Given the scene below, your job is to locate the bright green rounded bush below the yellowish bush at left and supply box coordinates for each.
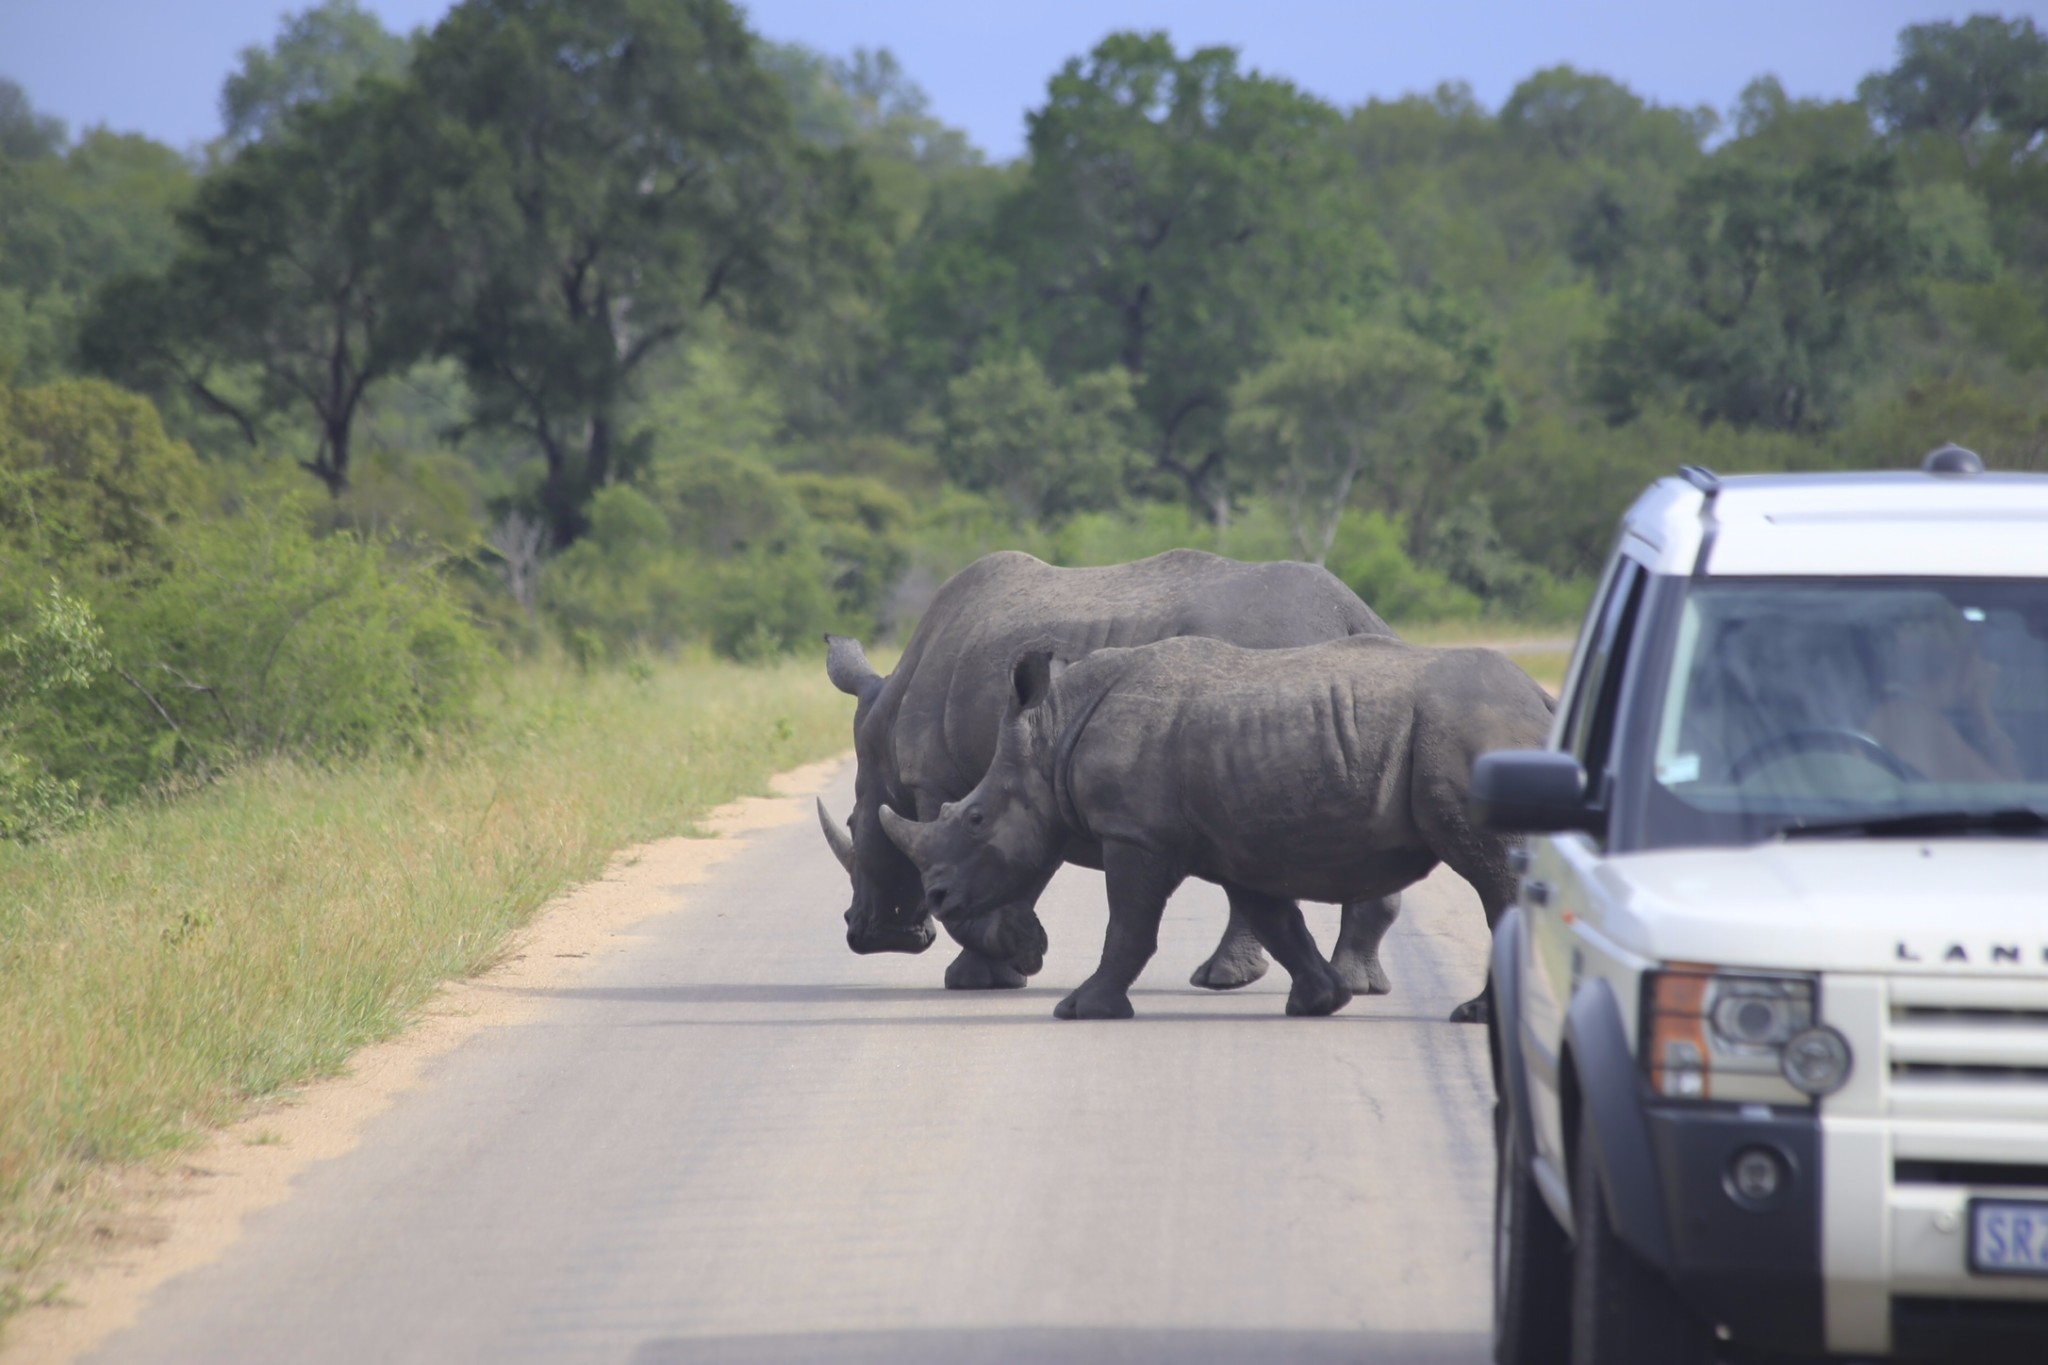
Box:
[35,505,489,800]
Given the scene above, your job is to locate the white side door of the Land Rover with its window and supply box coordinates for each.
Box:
[1522,551,1649,1177]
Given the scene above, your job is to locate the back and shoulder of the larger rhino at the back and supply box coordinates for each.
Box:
[874,551,1391,800]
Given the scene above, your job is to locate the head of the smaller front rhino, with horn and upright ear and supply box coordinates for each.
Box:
[881,651,1067,931]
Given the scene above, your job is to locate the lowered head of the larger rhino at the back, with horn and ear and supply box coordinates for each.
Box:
[817,634,938,954]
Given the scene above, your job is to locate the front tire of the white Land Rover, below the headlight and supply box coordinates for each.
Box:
[1571,1115,1718,1365]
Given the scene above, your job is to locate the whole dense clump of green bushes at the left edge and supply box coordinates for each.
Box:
[0,381,489,833]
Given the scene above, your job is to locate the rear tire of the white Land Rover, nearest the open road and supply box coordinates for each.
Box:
[1493,1099,1571,1365]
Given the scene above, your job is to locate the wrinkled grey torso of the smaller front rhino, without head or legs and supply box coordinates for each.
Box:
[1055,639,1548,900]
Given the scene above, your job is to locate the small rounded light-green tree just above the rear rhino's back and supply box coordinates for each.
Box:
[938,354,1145,522]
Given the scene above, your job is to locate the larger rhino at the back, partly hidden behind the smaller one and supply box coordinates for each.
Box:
[817,551,1399,993]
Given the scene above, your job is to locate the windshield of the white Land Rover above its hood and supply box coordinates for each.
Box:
[1645,579,2048,847]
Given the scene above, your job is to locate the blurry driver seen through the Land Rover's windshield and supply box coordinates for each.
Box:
[1864,604,2023,782]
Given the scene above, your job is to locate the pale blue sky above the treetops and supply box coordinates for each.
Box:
[0,0,2048,160]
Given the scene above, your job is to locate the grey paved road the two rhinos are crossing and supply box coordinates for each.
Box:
[92,774,1491,1365]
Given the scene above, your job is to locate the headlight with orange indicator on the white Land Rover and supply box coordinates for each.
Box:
[1640,968,1849,1105]
